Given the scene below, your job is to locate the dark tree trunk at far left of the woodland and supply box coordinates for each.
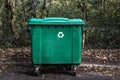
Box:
[3,0,13,36]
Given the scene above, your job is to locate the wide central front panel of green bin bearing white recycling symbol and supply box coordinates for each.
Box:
[41,26,72,64]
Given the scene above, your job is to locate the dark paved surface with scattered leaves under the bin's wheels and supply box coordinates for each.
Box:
[0,65,120,80]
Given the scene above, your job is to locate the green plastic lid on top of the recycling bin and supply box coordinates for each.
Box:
[28,17,85,25]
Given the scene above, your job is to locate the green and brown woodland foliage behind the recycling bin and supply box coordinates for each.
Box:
[0,0,120,48]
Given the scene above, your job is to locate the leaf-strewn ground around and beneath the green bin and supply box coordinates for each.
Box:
[0,48,120,80]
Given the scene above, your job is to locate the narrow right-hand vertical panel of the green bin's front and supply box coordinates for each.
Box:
[73,26,82,64]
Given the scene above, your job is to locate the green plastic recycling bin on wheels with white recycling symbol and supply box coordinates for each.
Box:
[28,17,85,75]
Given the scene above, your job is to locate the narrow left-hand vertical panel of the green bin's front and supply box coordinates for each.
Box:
[31,27,41,64]
